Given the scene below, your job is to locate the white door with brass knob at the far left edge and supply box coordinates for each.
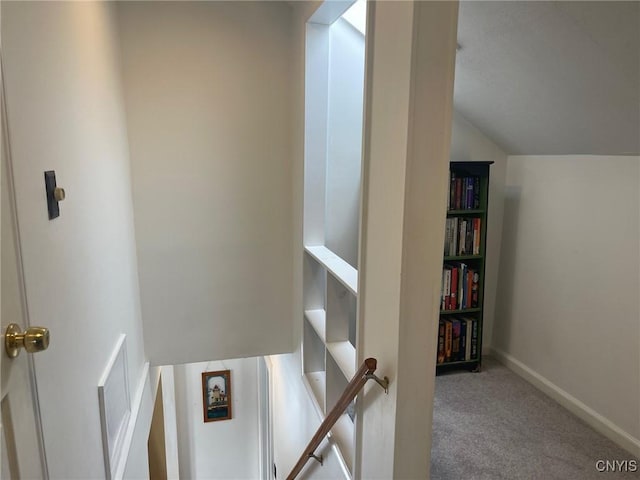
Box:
[0,65,47,480]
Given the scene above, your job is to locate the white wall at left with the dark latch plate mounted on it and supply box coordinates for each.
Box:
[1,2,148,478]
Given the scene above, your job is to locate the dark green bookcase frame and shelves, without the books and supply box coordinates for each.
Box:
[436,162,493,374]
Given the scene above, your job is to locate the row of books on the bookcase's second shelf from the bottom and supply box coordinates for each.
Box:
[440,262,480,310]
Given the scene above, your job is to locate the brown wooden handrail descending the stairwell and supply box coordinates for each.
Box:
[287,358,386,480]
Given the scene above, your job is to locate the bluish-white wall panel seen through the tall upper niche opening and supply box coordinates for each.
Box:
[325,19,364,268]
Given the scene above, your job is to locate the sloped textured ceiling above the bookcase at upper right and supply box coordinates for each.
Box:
[454,1,640,155]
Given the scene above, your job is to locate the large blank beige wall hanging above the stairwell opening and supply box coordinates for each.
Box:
[117,2,293,364]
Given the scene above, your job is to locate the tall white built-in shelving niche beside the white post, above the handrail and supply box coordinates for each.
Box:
[301,2,365,475]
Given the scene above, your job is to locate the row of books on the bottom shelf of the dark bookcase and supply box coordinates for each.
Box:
[437,317,478,364]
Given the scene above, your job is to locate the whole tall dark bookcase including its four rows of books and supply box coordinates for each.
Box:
[436,162,493,373]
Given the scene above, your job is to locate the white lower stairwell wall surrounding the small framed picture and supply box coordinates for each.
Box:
[174,358,260,480]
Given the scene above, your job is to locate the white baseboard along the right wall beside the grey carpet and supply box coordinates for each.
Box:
[488,348,640,458]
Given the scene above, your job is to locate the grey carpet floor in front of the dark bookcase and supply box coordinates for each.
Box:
[431,358,640,480]
